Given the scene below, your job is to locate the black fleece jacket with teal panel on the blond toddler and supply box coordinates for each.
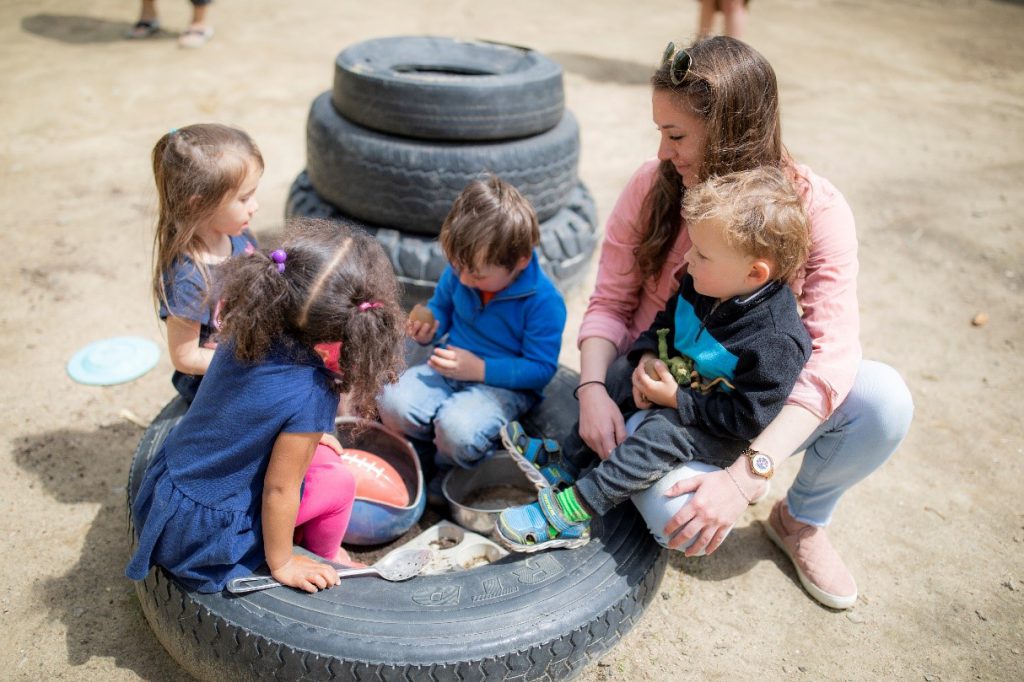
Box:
[629,274,811,440]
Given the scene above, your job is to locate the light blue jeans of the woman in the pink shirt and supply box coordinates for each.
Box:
[632,360,913,549]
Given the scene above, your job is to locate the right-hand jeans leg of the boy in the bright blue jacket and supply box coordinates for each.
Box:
[434,382,537,469]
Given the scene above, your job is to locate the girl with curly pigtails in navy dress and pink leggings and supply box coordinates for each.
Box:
[125,219,404,592]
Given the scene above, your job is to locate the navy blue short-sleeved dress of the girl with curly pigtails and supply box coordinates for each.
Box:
[125,342,338,592]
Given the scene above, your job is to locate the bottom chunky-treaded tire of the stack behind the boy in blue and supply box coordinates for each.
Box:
[285,171,598,306]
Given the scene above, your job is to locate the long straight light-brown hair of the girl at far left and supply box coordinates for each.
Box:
[153,123,263,305]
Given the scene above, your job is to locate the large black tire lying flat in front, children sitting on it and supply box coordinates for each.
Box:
[128,369,667,681]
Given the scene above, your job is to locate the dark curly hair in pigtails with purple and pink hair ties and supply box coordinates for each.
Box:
[218,218,406,417]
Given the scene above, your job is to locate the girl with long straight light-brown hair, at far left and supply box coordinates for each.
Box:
[153,123,263,402]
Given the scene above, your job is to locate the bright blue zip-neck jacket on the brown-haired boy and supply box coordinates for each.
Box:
[428,253,565,395]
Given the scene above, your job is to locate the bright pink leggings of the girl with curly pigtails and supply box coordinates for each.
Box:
[295,445,355,561]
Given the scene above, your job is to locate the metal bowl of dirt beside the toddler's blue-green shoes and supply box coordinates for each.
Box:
[441,452,537,535]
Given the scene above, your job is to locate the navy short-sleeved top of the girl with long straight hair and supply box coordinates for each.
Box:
[160,230,256,402]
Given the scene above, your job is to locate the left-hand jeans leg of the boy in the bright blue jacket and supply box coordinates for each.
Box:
[377,365,457,456]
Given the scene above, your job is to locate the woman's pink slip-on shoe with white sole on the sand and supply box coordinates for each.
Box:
[764,500,857,609]
